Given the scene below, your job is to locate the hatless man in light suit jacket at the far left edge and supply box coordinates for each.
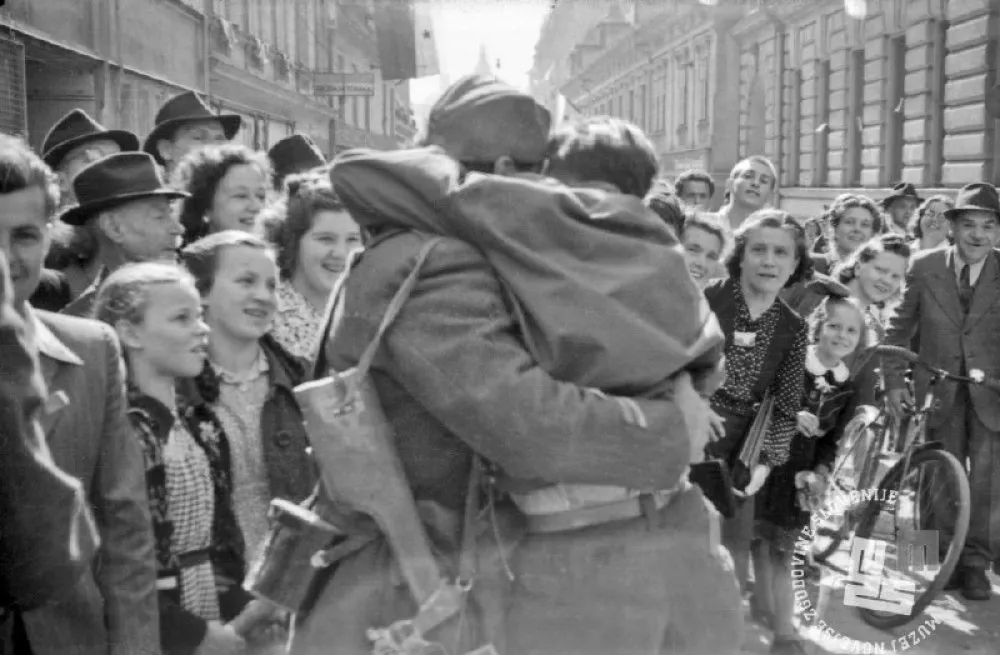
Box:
[0,136,159,655]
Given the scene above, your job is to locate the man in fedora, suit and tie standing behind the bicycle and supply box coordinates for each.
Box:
[883,182,1000,600]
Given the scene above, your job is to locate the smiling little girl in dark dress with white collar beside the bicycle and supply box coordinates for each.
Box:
[752,297,865,653]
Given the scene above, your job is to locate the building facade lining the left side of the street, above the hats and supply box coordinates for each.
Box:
[0,0,408,155]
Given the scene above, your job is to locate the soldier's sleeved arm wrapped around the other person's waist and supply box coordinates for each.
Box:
[342,236,701,489]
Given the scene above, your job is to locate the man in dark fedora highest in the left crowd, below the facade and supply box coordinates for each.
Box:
[142,91,243,176]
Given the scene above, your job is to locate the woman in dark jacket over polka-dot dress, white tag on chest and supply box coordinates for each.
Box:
[705,209,812,600]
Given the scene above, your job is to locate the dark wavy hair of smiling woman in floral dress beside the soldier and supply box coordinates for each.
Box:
[261,173,345,278]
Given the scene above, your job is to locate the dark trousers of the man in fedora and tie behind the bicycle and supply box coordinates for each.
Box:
[927,385,1000,569]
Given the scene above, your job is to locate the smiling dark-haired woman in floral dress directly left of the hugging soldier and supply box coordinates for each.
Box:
[261,173,361,360]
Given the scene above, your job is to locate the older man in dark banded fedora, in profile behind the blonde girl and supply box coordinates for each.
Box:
[59,152,188,316]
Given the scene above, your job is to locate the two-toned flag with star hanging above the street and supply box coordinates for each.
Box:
[375,0,440,80]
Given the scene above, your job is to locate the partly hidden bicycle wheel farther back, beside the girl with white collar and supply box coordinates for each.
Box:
[812,408,889,563]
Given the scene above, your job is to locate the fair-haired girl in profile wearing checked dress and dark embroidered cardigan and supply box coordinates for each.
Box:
[95,263,276,655]
